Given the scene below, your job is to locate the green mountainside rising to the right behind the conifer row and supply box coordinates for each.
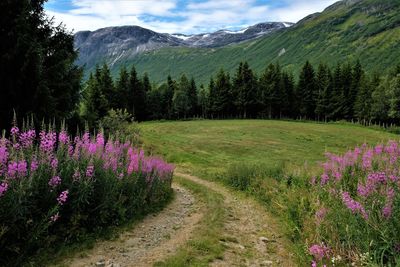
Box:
[108,0,400,82]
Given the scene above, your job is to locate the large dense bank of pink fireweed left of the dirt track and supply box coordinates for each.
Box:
[0,123,173,266]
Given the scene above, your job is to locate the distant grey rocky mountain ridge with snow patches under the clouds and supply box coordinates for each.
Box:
[75,22,293,73]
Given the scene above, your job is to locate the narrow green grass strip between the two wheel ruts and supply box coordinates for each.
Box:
[155,177,226,267]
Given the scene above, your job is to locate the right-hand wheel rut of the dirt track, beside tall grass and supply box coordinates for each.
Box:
[175,172,297,267]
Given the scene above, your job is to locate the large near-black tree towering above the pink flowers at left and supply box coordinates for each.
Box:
[0,0,82,129]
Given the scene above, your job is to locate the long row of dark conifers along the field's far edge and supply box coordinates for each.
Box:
[81,61,400,125]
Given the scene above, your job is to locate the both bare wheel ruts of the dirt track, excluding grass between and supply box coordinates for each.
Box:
[63,173,296,267]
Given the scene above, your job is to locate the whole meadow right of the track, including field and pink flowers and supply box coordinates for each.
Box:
[140,120,399,266]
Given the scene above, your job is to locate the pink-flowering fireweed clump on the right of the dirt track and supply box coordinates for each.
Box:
[310,141,400,266]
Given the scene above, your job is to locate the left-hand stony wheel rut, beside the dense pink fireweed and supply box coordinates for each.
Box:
[62,184,202,267]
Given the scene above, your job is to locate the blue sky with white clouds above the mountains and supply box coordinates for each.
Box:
[45,0,337,34]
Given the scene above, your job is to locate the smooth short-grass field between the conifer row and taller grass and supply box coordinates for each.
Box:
[140,120,398,178]
